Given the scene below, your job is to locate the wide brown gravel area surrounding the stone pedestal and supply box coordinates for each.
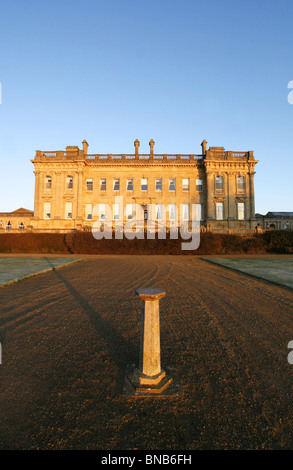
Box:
[0,256,293,450]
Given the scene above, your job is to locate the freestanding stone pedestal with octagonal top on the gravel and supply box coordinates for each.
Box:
[128,289,172,394]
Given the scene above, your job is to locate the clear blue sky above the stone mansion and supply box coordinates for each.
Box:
[0,0,293,213]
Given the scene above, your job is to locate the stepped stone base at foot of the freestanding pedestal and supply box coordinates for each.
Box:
[125,365,173,395]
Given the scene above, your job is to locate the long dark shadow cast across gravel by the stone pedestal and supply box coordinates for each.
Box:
[46,258,139,393]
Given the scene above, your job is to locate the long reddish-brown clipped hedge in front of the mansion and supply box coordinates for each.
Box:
[0,230,293,256]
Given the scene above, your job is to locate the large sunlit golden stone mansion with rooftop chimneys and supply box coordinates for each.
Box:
[0,140,257,232]
